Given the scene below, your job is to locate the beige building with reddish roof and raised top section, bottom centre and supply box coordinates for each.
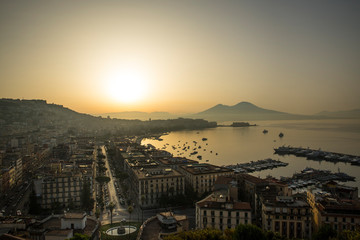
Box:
[195,191,251,230]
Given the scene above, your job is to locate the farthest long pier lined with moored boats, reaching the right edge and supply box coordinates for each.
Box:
[274,146,360,166]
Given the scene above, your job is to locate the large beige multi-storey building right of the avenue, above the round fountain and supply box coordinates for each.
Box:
[130,167,185,208]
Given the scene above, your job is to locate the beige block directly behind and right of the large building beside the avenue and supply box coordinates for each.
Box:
[179,163,234,195]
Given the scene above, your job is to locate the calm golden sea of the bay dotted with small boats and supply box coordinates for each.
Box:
[141,119,360,191]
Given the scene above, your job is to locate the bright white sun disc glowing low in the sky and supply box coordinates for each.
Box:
[107,68,147,104]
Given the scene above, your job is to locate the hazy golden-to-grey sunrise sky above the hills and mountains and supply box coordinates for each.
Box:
[0,0,360,114]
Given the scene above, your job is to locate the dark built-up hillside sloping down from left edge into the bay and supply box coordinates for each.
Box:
[0,99,216,136]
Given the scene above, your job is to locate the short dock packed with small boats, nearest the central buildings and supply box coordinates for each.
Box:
[224,158,289,173]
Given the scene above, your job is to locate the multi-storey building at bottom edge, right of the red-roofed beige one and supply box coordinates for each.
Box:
[261,196,312,239]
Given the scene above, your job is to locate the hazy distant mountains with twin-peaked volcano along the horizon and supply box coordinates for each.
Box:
[99,102,360,122]
